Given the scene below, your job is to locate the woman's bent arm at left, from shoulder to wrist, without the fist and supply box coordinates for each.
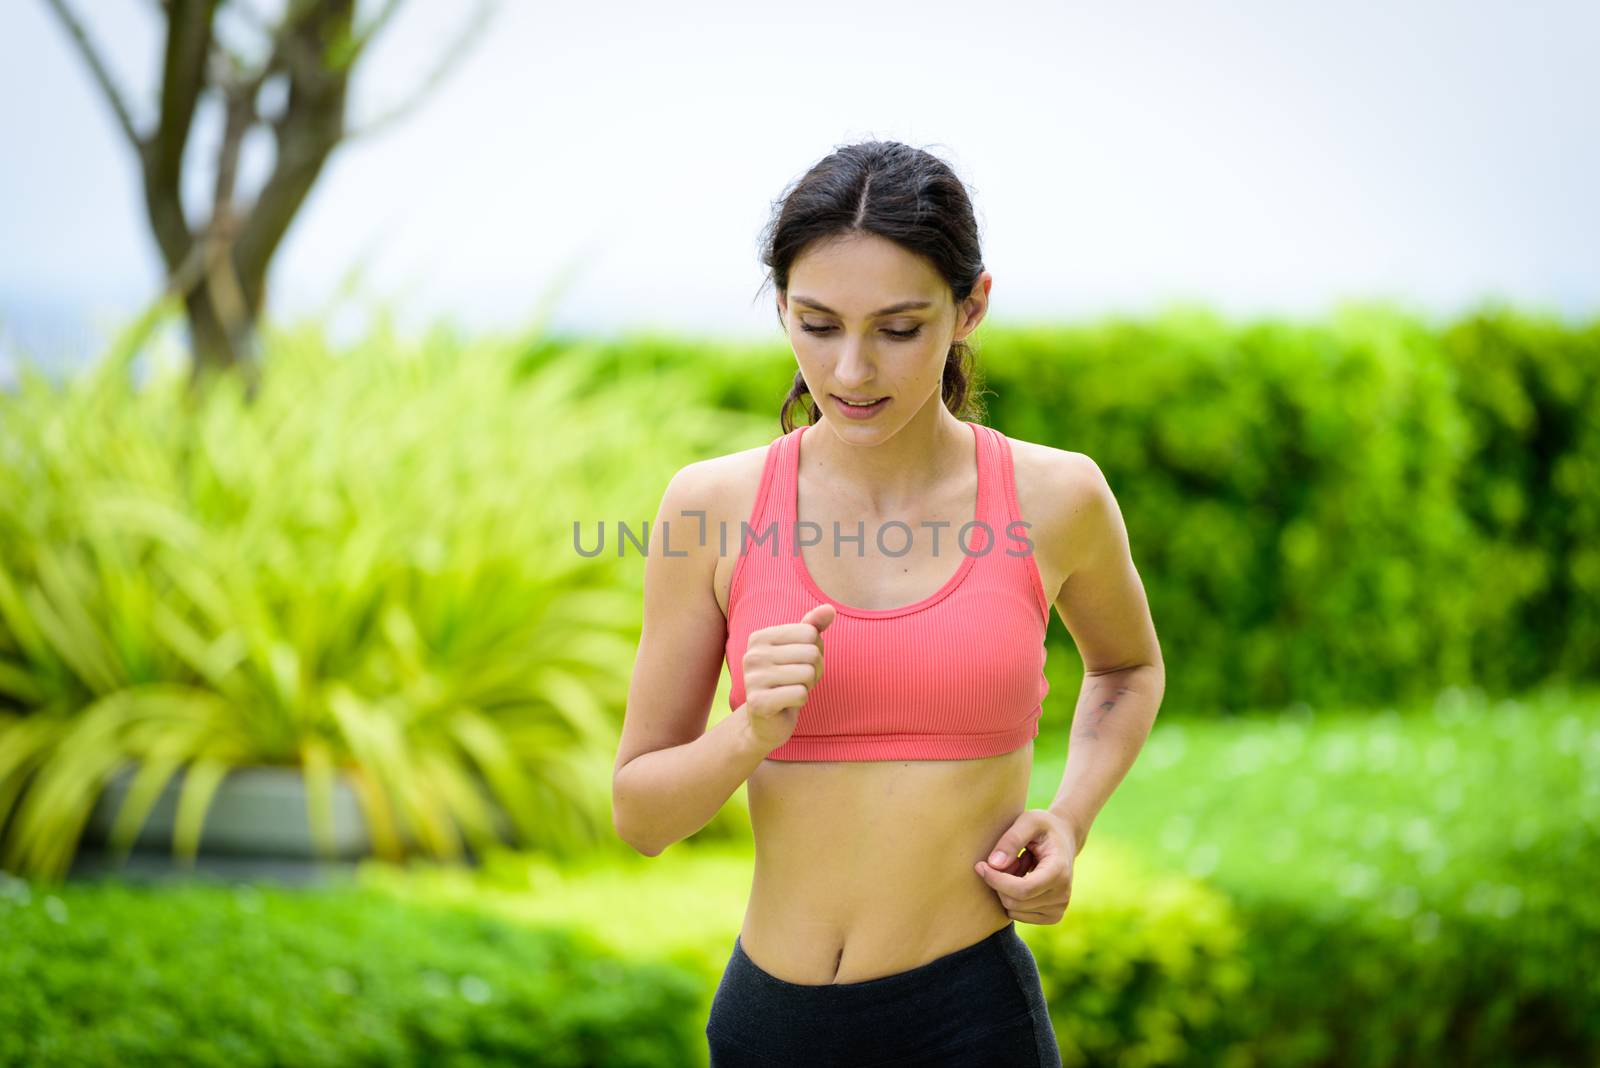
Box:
[611,460,770,857]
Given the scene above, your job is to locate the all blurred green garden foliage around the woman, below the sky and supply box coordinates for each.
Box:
[0,295,1600,1065]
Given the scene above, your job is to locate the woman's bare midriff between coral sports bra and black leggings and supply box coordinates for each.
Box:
[739,742,1034,985]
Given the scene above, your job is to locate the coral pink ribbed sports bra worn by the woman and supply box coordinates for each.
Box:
[725,420,1050,761]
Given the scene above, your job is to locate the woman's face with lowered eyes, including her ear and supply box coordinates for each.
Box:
[778,235,990,428]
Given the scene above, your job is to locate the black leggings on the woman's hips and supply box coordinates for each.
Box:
[706,921,1061,1068]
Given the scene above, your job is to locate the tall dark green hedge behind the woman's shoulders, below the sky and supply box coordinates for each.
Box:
[630,305,1600,711]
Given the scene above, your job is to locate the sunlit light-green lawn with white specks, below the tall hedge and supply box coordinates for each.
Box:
[1029,689,1600,924]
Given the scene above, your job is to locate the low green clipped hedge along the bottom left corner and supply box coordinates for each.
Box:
[0,876,706,1068]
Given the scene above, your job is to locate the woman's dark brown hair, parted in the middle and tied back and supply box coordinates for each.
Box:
[762,141,984,433]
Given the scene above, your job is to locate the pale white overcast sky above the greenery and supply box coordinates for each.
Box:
[0,0,1600,370]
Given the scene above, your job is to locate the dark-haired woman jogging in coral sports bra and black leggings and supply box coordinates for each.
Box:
[613,142,1165,1068]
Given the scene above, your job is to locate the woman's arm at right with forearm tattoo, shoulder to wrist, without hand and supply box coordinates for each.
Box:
[1048,452,1166,851]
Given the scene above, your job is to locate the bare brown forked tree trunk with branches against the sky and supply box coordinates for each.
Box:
[46,0,486,381]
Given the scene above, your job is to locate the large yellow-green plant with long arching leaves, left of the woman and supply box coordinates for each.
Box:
[0,294,771,879]
